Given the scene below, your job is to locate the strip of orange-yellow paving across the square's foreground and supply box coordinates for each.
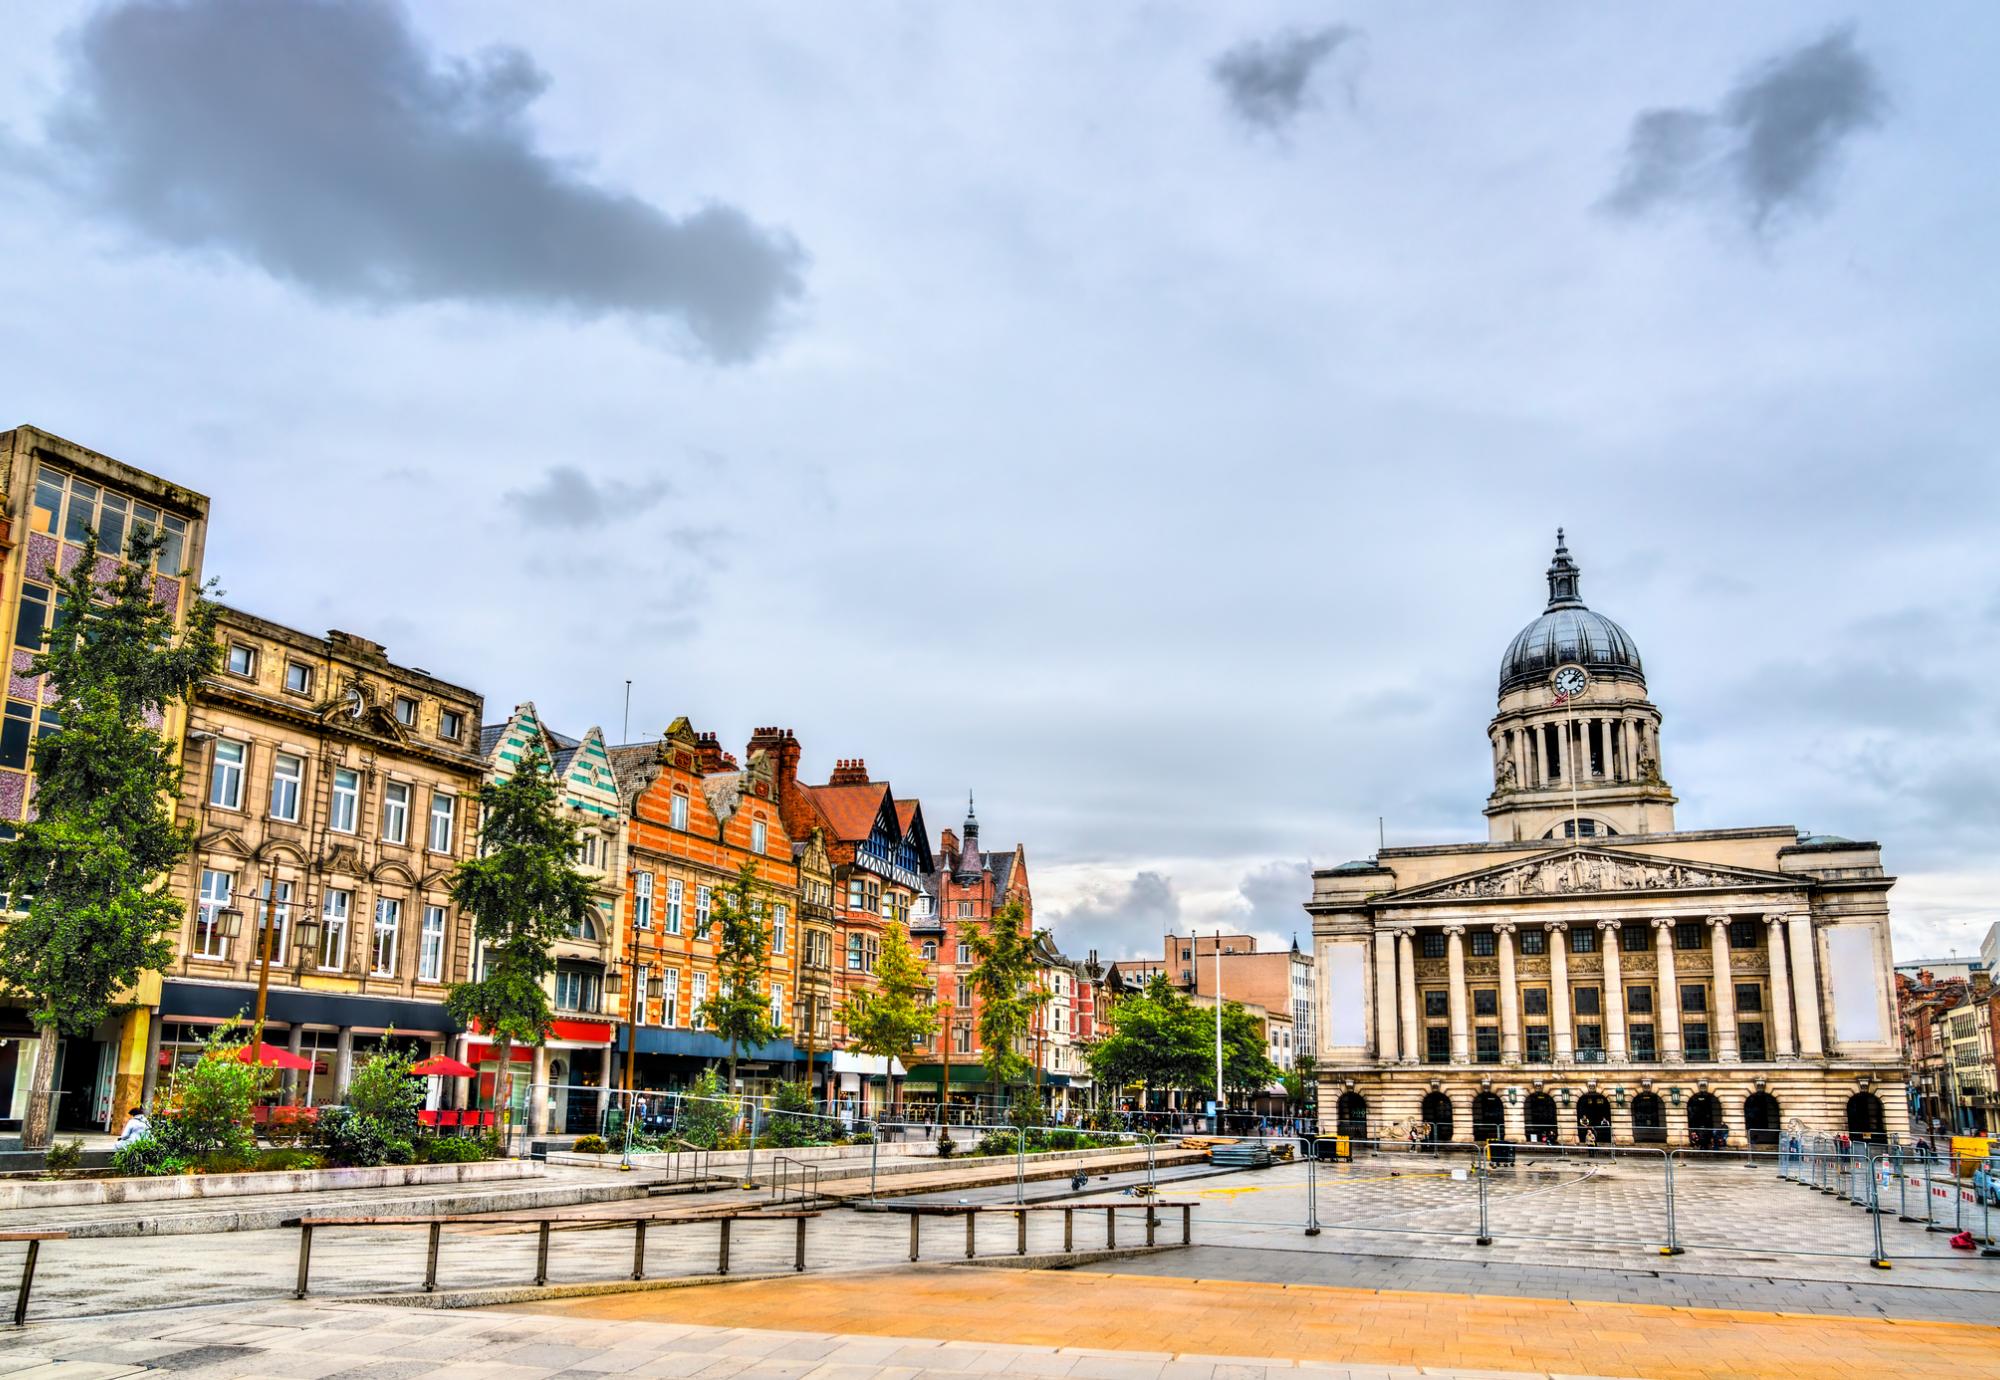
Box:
[508,1266,2000,1380]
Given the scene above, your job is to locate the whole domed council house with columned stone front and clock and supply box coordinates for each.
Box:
[1306,532,1904,1146]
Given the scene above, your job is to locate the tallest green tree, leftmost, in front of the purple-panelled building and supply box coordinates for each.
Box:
[0,528,222,1150]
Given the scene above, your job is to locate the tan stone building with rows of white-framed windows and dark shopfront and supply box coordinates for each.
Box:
[165,608,484,1102]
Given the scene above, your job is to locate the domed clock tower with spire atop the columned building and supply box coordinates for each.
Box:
[1486,528,1674,842]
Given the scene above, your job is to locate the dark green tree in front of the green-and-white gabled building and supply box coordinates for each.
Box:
[444,740,596,1136]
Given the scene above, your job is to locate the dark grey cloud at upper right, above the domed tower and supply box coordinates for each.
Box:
[1604,28,1888,230]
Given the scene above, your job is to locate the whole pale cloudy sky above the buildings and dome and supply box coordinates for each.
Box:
[0,0,2000,958]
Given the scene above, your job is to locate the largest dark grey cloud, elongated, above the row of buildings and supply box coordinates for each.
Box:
[25,0,804,362]
